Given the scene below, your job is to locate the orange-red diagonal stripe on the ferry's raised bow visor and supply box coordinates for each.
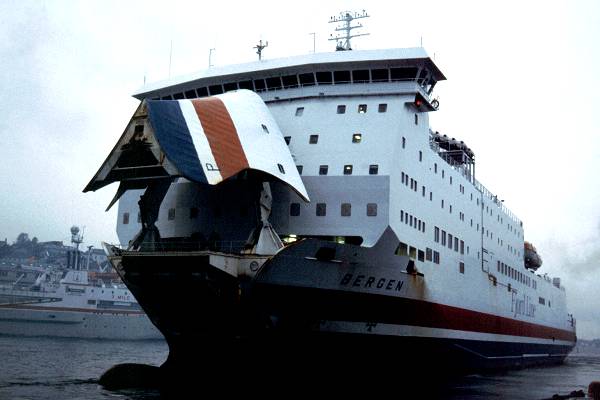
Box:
[192,97,249,180]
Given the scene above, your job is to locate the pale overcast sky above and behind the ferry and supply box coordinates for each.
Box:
[0,0,600,337]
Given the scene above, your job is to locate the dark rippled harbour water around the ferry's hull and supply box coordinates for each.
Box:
[0,336,600,400]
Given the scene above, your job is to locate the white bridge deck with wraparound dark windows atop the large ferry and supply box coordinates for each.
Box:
[134,47,446,111]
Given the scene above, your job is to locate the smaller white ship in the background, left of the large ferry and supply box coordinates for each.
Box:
[0,227,162,340]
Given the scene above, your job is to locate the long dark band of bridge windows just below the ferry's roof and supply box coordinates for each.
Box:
[154,67,435,100]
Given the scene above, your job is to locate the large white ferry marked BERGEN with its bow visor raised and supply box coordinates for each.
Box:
[84,13,576,378]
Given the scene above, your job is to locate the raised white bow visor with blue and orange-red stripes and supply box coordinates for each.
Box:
[84,90,309,208]
